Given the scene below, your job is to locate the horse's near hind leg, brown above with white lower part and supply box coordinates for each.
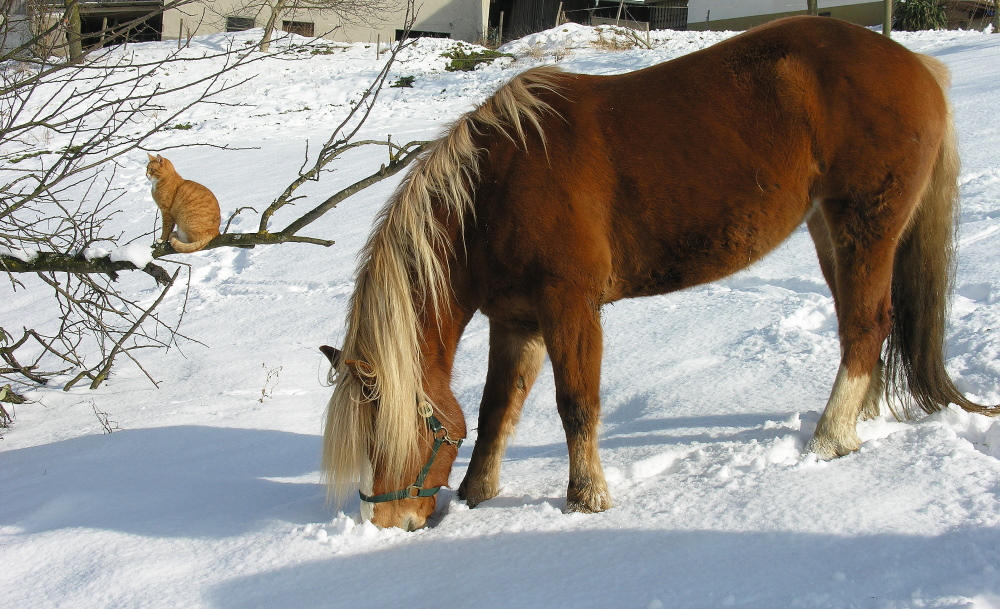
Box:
[808,201,906,459]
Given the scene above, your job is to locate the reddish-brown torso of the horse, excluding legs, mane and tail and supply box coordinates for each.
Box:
[468,18,947,312]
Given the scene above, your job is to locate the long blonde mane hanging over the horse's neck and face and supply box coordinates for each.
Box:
[323,67,561,501]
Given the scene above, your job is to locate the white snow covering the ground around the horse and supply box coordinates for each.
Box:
[0,26,1000,609]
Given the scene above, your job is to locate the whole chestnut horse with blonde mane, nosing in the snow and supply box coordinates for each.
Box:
[323,17,992,529]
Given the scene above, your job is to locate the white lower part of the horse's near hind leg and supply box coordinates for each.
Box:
[807,365,872,459]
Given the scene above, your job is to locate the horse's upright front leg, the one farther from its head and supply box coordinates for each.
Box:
[539,286,612,512]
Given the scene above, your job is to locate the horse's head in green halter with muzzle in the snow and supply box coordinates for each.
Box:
[320,345,465,531]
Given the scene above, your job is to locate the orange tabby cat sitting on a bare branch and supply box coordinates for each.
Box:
[146,153,222,254]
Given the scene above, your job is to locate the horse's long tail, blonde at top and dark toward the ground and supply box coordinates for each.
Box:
[885,55,998,418]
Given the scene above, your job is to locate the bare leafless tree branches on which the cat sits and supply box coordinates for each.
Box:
[0,0,426,389]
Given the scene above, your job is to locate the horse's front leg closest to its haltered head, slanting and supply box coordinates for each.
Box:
[458,320,545,507]
